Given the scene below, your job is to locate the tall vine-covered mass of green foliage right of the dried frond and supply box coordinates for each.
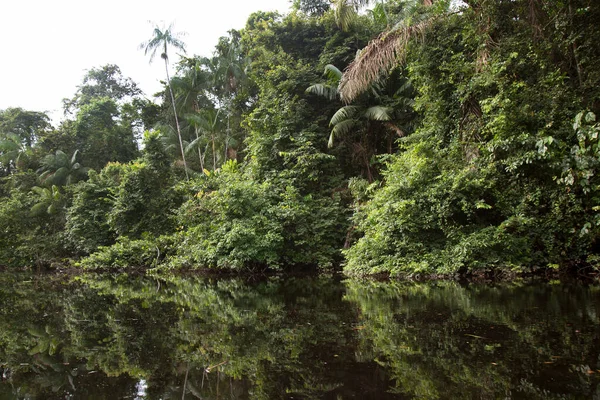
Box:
[346,2,598,275]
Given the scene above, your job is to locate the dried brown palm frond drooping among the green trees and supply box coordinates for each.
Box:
[339,18,436,102]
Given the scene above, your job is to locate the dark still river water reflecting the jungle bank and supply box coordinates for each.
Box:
[0,274,600,400]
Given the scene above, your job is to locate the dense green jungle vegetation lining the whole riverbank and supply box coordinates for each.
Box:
[0,0,600,276]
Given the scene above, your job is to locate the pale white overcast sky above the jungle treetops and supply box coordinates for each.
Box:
[0,0,290,123]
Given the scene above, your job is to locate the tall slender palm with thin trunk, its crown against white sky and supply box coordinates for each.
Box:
[140,24,189,179]
